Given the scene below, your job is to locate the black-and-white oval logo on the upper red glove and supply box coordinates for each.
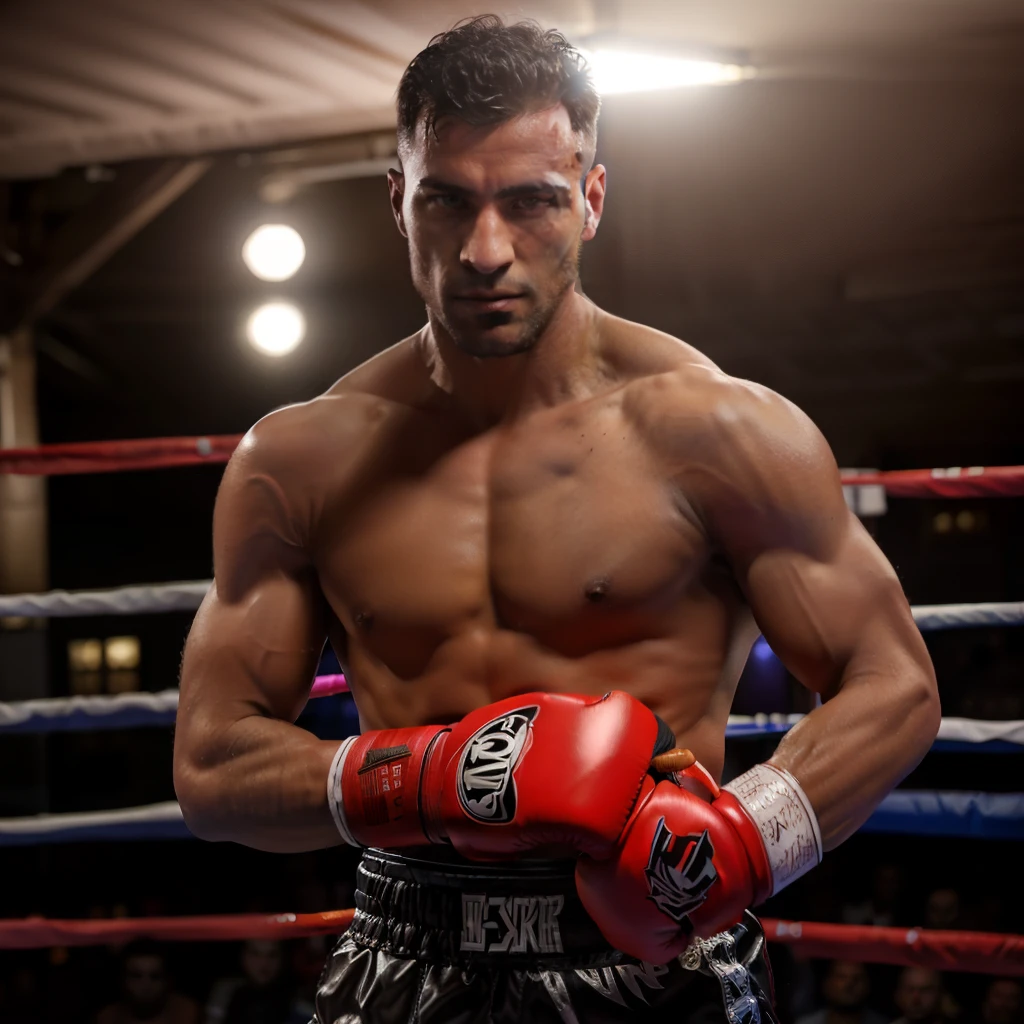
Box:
[456,705,541,825]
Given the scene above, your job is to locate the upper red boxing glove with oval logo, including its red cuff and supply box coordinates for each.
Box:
[328,691,672,860]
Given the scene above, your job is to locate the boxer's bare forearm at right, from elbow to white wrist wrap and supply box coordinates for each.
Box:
[771,659,941,850]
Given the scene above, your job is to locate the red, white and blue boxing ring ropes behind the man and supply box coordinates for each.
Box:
[0,436,1024,976]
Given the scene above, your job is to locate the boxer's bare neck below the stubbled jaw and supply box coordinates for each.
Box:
[418,291,599,429]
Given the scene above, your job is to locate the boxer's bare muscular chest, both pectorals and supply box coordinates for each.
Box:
[317,399,707,677]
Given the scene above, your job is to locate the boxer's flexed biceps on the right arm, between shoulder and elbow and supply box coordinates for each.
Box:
[744,517,922,692]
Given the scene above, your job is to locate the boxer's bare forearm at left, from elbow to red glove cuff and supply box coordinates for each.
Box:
[174,715,341,853]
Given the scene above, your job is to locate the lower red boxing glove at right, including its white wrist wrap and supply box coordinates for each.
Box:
[577,764,821,964]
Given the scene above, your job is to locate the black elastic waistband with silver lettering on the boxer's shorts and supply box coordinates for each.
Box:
[348,849,625,970]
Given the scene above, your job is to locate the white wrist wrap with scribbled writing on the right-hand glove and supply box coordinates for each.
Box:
[722,764,821,896]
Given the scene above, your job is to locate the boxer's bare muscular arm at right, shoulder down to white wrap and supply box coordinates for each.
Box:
[685,382,941,849]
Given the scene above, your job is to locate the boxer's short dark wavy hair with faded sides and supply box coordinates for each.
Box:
[398,14,601,158]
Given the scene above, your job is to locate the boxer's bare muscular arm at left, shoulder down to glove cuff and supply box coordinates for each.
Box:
[174,424,339,852]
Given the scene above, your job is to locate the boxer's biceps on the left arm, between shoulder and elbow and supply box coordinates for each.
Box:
[179,570,326,721]
